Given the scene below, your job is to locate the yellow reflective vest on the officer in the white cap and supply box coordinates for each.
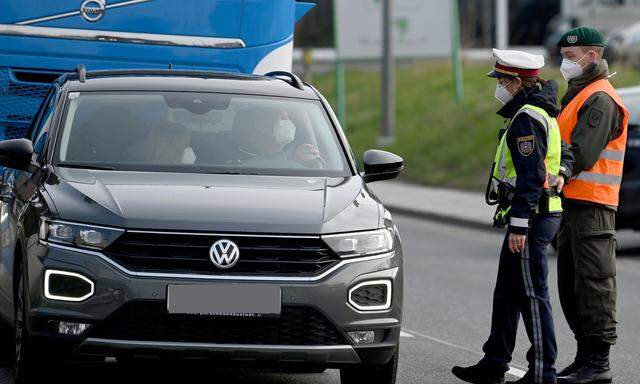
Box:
[492,104,562,212]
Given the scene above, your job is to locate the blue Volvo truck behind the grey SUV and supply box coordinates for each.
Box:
[0,0,314,140]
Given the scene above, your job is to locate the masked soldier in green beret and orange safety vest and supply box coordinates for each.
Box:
[558,27,629,384]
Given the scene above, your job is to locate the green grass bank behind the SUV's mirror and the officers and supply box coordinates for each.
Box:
[313,61,640,190]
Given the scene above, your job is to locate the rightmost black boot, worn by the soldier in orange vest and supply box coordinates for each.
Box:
[558,343,613,384]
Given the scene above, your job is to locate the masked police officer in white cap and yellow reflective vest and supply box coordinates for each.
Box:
[452,49,570,384]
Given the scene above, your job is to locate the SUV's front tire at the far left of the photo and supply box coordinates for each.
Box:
[13,274,49,384]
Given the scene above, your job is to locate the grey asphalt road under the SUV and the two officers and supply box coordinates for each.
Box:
[0,216,640,384]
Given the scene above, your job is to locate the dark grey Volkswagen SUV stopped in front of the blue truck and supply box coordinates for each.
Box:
[0,66,403,384]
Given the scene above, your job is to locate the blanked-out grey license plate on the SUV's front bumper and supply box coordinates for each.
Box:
[167,284,282,317]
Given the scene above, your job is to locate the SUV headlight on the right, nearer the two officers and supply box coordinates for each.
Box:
[322,228,393,258]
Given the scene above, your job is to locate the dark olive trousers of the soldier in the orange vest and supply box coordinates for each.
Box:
[558,205,617,344]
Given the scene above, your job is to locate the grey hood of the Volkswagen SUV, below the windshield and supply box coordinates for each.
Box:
[45,168,382,234]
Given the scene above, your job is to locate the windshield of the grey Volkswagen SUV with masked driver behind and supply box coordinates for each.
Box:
[55,92,351,177]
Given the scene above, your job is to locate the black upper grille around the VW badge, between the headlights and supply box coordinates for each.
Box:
[105,232,340,276]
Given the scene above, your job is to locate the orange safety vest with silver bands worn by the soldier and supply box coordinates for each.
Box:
[558,79,629,207]
